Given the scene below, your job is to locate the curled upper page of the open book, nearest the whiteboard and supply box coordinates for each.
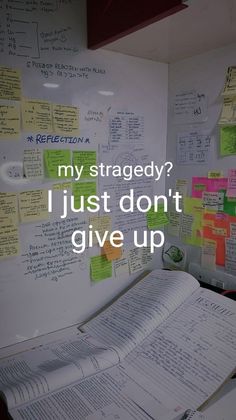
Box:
[83,270,199,358]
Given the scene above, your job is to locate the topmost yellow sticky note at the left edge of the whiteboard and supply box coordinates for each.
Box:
[0,67,21,101]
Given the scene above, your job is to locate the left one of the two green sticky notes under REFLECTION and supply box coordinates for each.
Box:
[43,150,72,179]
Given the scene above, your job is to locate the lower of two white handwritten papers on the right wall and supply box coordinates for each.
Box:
[177,131,212,165]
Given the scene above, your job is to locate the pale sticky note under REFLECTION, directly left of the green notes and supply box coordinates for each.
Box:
[23,149,44,179]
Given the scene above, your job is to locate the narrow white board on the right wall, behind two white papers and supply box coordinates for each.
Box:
[166,44,236,281]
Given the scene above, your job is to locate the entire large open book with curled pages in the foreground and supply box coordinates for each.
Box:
[0,270,236,420]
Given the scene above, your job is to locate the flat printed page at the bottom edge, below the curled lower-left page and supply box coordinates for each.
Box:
[10,366,173,420]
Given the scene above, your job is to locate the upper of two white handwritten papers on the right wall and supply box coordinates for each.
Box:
[174,90,207,123]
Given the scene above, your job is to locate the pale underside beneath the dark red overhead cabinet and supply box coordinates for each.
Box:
[105,0,236,63]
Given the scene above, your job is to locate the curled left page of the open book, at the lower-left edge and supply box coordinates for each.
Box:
[0,332,119,408]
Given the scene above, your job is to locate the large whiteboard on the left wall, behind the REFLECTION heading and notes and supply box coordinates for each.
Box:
[0,0,168,347]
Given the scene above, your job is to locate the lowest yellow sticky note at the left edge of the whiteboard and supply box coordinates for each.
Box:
[0,224,20,259]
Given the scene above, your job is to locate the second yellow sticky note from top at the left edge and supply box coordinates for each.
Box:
[0,105,20,140]
